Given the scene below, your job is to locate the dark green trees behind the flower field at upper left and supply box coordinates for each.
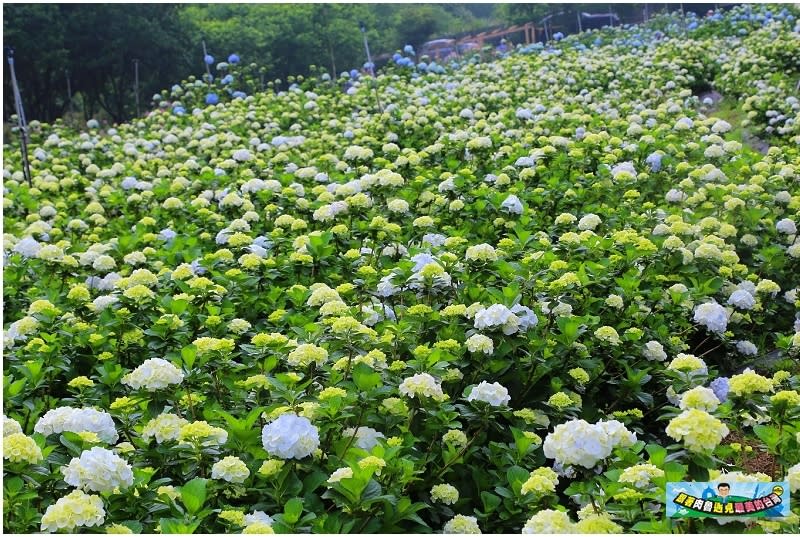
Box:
[3,4,493,122]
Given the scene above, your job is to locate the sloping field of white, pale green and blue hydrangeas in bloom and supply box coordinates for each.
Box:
[3,5,800,534]
